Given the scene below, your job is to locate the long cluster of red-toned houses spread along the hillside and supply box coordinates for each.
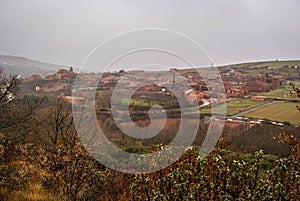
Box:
[26,67,286,102]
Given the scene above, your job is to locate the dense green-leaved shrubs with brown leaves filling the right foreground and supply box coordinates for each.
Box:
[131,150,300,200]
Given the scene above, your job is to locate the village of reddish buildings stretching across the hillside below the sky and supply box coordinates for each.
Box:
[22,67,286,102]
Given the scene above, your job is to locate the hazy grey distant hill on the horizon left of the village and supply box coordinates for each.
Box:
[0,55,68,78]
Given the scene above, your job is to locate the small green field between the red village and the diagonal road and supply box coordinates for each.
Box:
[200,99,266,116]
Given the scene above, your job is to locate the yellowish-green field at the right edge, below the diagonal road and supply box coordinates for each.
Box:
[243,102,300,125]
